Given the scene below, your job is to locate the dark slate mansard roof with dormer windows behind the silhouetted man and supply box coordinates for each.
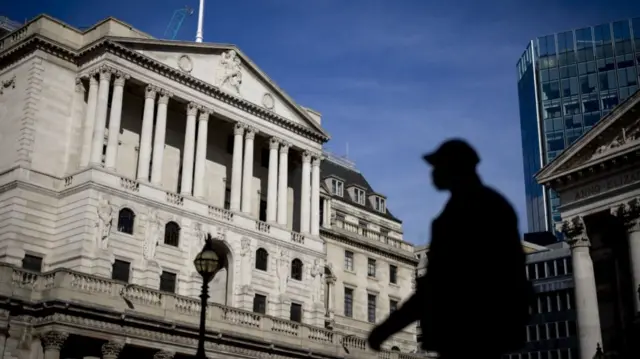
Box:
[320,158,402,223]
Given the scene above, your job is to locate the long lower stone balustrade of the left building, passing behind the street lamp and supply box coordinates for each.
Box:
[0,264,436,359]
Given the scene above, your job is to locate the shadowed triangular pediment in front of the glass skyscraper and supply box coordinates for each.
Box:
[536,91,640,184]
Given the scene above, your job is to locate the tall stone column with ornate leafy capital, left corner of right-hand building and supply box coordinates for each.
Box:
[561,217,602,359]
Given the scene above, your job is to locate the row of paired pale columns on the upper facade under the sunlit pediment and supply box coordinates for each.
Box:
[80,66,322,236]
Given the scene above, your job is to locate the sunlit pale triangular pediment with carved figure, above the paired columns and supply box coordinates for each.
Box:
[110,38,328,137]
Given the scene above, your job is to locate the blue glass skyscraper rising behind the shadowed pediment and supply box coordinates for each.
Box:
[517,18,640,236]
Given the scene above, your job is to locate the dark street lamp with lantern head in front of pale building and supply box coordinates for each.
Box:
[193,233,224,359]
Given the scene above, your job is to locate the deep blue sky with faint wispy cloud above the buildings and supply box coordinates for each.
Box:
[0,0,640,244]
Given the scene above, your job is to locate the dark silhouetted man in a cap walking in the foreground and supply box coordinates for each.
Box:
[369,140,532,359]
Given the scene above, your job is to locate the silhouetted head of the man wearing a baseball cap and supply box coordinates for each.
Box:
[423,139,480,191]
